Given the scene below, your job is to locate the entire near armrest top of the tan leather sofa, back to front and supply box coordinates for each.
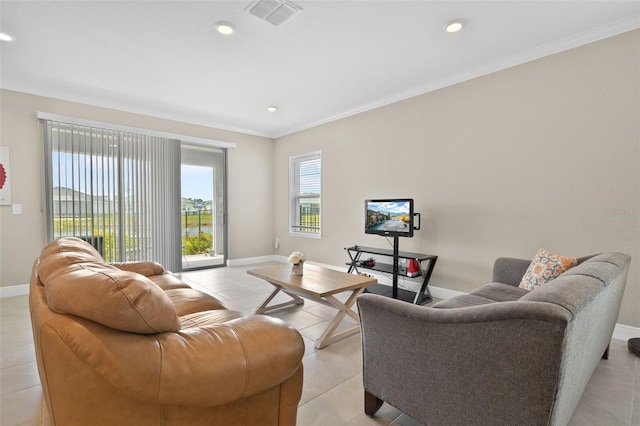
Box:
[40,312,304,406]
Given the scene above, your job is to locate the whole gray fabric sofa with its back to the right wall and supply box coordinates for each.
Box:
[358,253,631,426]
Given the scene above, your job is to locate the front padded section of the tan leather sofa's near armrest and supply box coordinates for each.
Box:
[157,315,304,406]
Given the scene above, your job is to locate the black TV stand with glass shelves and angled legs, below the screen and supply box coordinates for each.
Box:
[345,237,438,305]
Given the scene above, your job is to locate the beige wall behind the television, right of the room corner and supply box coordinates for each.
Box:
[275,31,640,327]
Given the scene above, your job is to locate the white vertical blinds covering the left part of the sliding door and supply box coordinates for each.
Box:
[44,120,182,271]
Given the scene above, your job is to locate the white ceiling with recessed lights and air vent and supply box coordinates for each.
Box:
[0,0,640,137]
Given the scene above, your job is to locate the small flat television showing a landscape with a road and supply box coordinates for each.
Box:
[364,198,414,237]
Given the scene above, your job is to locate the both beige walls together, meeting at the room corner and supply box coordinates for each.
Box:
[0,31,640,327]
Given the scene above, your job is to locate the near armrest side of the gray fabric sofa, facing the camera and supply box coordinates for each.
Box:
[358,294,571,425]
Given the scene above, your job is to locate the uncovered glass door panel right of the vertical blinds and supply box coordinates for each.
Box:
[180,144,226,270]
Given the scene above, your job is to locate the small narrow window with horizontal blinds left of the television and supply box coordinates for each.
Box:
[289,152,322,238]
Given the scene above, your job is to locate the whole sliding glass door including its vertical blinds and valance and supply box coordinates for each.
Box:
[39,114,234,272]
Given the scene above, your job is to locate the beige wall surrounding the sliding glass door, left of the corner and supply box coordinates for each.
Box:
[0,90,274,287]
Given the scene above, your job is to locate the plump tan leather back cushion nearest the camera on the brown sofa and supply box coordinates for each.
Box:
[38,262,180,334]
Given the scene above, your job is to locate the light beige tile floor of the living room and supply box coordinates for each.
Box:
[0,265,640,426]
